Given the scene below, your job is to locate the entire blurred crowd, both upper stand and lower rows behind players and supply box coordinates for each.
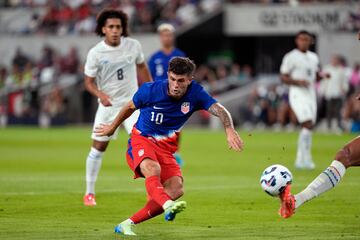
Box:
[0,0,360,132]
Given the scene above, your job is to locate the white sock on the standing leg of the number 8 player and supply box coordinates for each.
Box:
[86,147,104,194]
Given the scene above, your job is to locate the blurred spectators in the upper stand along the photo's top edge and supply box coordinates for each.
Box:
[0,0,360,35]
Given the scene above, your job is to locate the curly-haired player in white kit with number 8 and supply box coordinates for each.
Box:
[83,9,151,206]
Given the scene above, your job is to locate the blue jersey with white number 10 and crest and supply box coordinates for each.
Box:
[133,80,217,150]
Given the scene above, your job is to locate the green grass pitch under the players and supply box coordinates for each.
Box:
[0,127,360,240]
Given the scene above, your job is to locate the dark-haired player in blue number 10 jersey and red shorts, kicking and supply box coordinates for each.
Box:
[95,57,243,235]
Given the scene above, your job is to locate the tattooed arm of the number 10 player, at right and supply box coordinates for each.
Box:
[208,103,244,151]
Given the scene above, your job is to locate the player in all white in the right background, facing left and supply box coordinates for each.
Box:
[280,31,330,169]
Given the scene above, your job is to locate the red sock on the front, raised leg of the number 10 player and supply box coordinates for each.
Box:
[145,176,171,206]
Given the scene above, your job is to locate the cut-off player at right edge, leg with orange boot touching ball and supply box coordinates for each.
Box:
[279,94,360,218]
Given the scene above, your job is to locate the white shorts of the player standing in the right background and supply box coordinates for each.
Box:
[289,94,317,124]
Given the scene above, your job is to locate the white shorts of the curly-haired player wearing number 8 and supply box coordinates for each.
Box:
[91,103,139,142]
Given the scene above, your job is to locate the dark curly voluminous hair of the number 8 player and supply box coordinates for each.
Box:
[95,9,129,37]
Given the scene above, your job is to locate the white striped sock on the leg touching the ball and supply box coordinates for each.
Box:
[295,160,346,208]
